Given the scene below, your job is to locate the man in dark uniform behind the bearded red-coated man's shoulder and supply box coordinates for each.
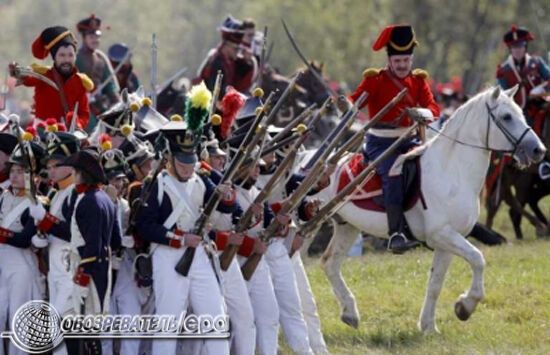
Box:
[76,14,120,132]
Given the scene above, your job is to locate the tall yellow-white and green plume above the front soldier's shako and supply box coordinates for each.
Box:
[185,81,212,137]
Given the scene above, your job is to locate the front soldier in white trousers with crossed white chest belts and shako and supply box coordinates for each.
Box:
[136,122,234,355]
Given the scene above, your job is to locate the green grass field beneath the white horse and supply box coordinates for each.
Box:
[300,208,550,354]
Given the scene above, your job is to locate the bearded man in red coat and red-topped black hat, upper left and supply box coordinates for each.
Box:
[9,26,94,128]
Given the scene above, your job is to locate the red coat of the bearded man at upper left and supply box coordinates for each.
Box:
[22,65,94,128]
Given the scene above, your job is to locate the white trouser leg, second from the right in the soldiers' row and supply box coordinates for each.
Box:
[265,238,313,354]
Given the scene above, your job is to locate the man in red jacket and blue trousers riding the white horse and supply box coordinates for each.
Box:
[350,25,439,253]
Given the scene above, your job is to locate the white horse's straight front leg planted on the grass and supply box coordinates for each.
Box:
[418,248,453,333]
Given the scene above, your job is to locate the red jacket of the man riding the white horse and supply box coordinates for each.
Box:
[350,69,439,127]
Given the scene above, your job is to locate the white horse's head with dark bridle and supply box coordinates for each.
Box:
[485,85,546,167]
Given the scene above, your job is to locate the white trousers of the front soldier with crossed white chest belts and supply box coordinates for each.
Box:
[153,245,229,355]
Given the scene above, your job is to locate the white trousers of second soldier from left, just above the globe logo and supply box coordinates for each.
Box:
[48,236,74,355]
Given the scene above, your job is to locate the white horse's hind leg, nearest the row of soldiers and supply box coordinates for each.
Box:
[321,222,359,328]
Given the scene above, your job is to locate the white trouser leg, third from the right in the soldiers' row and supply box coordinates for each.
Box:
[238,255,279,355]
